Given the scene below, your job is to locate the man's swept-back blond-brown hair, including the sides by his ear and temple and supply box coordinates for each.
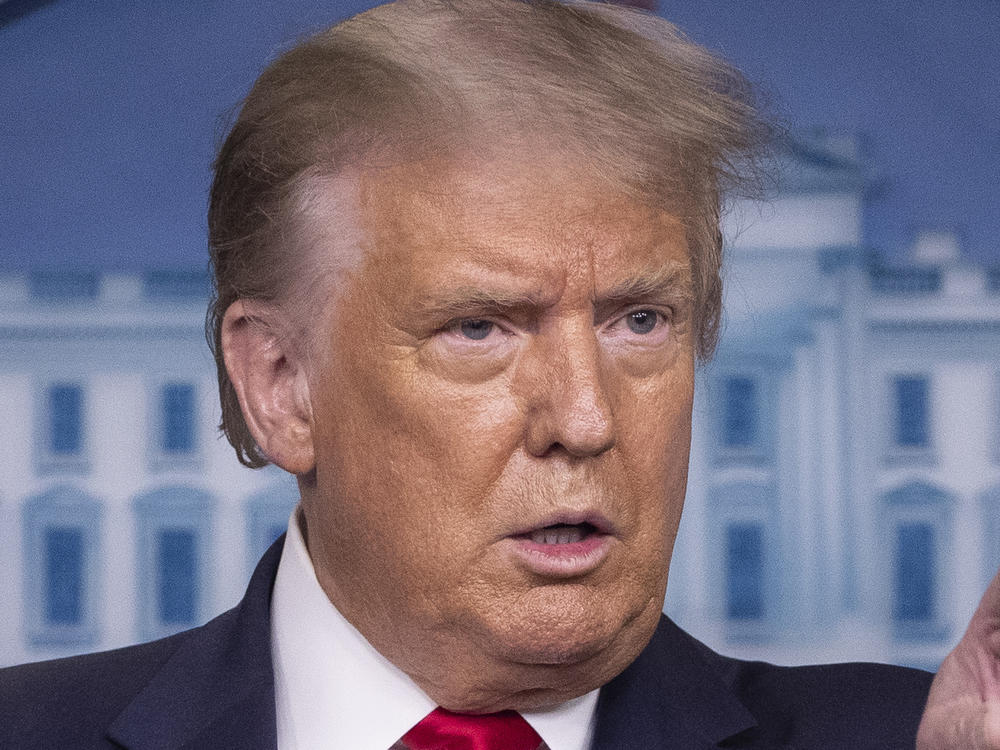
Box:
[206,0,769,467]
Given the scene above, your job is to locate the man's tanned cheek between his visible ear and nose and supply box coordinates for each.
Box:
[315,336,521,547]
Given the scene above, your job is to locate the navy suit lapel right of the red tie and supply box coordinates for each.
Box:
[593,617,756,750]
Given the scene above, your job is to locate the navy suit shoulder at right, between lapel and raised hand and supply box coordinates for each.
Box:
[706,649,933,750]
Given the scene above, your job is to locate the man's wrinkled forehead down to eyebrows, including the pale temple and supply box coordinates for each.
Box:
[282,150,695,370]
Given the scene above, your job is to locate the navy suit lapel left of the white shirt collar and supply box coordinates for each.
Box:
[108,537,284,750]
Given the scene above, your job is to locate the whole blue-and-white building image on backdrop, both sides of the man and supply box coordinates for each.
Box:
[0,135,1000,668]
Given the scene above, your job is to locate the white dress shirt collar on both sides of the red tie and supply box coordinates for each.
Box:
[271,509,598,750]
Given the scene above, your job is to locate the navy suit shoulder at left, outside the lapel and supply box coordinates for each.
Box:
[0,633,185,748]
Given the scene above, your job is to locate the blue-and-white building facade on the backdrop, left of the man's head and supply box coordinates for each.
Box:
[0,271,297,664]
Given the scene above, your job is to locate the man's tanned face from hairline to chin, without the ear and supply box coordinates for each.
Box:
[303,161,694,711]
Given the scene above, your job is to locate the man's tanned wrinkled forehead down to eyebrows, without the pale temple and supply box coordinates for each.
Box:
[328,159,692,332]
